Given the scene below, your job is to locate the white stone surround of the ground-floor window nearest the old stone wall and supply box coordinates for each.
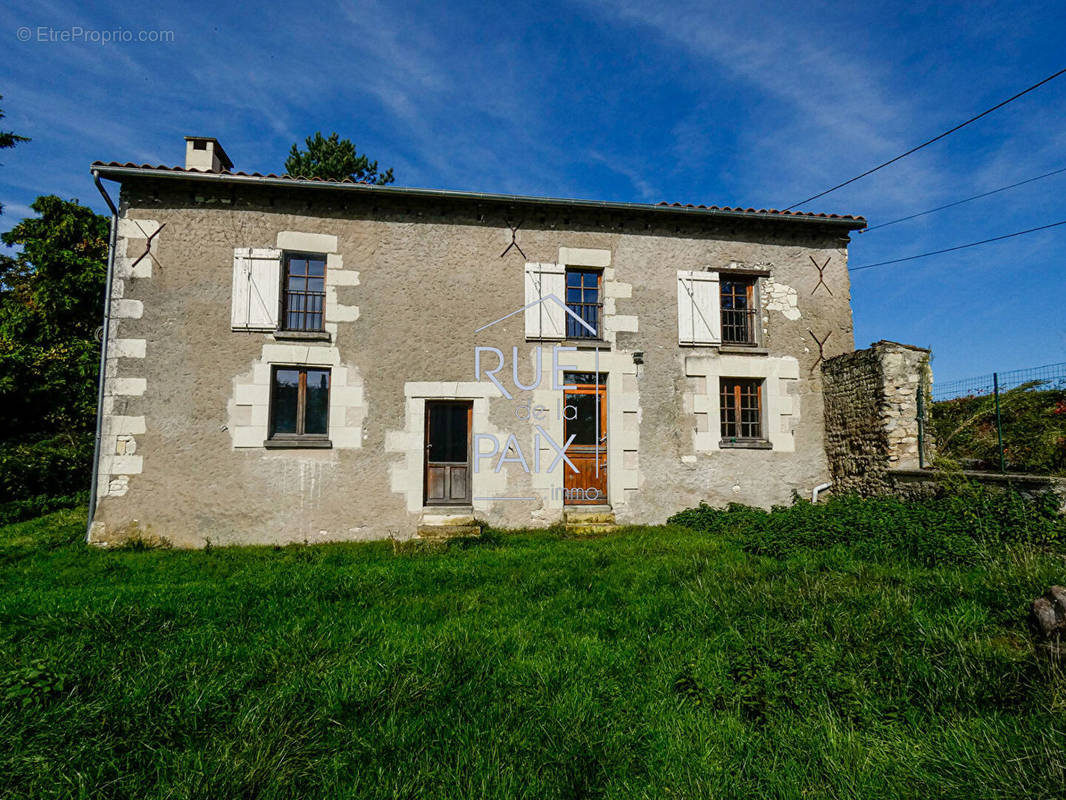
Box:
[682,354,800,453]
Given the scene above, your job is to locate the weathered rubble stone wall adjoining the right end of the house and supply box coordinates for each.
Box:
[822,341,934,494]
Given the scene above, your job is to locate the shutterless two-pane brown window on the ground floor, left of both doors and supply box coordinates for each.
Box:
[267,367,329,447]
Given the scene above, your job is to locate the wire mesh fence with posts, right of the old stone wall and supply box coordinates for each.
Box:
[932,362,1066,475]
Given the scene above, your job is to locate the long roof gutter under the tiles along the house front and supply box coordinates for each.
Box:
[93,165,867,230]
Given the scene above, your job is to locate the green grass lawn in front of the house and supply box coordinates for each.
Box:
[0,510,1066,800]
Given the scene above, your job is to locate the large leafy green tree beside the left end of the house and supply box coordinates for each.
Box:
[0,195,109,441]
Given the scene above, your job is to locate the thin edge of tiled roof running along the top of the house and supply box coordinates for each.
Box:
[92,161,866,229]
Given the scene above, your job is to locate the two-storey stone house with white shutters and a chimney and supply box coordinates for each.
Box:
[91,138,866,546]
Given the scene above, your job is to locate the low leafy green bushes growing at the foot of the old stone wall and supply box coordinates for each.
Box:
[669,486,1066,566]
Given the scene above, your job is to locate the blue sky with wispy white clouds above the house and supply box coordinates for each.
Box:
[0,0,1066,382]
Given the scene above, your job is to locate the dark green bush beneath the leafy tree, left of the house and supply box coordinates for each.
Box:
[0,432,93,502]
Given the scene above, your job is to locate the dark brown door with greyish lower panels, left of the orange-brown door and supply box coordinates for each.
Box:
[425,400,473,506]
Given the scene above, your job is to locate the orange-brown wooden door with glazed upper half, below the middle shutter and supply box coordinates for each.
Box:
[563,373,608,506]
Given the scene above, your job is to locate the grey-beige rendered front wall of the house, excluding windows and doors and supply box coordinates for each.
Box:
[93,180,853,546]
